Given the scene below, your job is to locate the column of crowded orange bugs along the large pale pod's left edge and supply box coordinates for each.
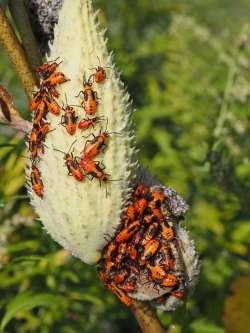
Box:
[28,57,68,198]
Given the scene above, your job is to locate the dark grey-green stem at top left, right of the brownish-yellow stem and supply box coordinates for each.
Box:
[8,0,42,73]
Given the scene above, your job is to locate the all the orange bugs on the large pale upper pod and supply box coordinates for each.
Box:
[28,58,113,198]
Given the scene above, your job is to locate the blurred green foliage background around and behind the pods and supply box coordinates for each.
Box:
[0,0,250,333]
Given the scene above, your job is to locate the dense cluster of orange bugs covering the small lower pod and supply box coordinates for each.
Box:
[97,184,184,306]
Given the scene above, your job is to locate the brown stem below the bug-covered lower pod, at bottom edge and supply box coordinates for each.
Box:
[131,302,165,333]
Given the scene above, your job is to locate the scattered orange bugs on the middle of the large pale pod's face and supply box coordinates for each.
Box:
[52,58,114,188]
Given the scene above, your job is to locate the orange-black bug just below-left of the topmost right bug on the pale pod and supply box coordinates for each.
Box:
[76,79,98,116]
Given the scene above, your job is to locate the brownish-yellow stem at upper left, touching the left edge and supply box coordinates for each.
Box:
[0,8,36,99]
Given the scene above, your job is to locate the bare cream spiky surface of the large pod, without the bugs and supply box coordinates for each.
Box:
[28,0,137,264]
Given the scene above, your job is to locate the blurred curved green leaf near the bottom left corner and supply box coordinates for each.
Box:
[0,292,62,330]
